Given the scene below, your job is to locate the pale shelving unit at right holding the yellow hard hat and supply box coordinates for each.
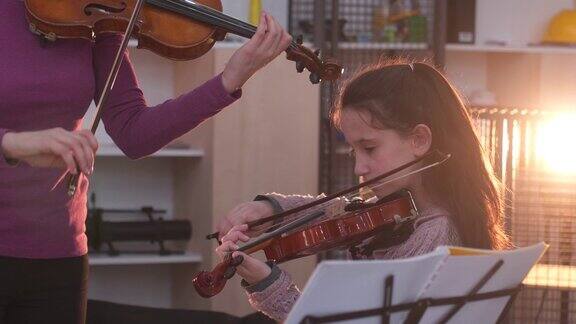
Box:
[446,0,576,110]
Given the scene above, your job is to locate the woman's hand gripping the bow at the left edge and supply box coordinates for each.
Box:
[0,128,98,175]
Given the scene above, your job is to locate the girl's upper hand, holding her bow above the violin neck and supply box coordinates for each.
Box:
[216,200,274,239]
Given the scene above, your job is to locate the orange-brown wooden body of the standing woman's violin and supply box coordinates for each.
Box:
[26,0,226,60]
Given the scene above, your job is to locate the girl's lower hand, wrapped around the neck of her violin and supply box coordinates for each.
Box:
[216,224,272,285]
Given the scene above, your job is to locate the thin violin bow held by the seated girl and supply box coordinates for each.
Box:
[206,150,451,240]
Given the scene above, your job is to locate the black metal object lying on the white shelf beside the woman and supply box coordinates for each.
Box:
[86,207,192,256]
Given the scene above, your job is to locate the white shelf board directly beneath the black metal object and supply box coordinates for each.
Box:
[88,252,202,266]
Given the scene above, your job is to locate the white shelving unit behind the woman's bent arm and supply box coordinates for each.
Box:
[84,41,205,308]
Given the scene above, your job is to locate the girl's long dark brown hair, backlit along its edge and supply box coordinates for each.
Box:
[332,59,510,249]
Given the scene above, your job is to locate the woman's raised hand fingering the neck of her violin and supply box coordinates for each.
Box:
[222,12,292,93]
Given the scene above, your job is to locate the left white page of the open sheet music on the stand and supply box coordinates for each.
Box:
[285,251,446,324]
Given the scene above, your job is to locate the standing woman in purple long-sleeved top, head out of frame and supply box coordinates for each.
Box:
[0,0,291,324]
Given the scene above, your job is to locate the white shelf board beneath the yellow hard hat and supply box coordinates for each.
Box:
[446,44,576,54]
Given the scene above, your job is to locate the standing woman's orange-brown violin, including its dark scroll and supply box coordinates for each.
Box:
[25,0,342,83]
